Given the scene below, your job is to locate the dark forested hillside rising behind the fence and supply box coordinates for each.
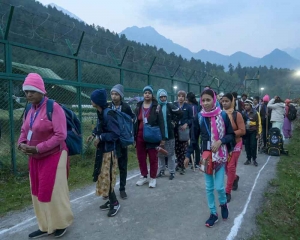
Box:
[0,0,300,97]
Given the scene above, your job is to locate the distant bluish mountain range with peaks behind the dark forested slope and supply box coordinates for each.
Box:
[120,26,300,69]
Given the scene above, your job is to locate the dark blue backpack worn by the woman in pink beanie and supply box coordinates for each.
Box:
[25,99,82,156]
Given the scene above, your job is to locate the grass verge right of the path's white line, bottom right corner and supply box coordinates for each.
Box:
[251,123,300,240]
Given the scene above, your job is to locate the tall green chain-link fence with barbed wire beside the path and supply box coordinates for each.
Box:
[0,2,244,174]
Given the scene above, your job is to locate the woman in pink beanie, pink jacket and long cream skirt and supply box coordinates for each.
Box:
[18,73,73,238]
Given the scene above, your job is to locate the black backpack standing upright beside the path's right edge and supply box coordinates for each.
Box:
[266,128,283,156]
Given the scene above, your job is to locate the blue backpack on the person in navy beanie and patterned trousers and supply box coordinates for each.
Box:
[104,108,134,147]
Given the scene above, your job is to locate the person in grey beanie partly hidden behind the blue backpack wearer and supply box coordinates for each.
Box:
[108,84,135,199]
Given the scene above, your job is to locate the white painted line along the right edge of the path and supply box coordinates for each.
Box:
[226,156,271,240]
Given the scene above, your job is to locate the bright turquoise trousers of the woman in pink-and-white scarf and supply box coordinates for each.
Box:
[205,165,227,214]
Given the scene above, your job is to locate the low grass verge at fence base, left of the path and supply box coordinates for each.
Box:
[0,147,138,217]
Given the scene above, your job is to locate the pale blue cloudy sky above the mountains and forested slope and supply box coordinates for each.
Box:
[39,0,300,57]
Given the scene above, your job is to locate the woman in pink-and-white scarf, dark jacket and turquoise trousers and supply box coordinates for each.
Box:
[184,89,235,227]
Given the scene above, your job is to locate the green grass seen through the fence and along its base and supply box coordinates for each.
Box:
[0,109,138,216]
